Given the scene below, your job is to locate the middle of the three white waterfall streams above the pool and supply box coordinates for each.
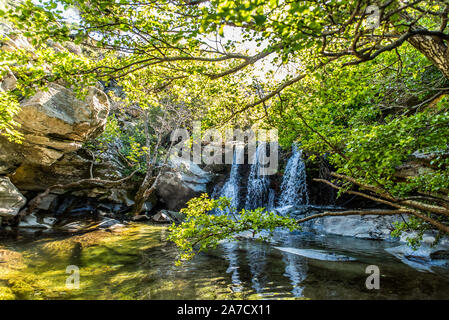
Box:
[245,143,275,210]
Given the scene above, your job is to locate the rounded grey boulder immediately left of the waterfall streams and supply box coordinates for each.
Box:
[156,159,212,211]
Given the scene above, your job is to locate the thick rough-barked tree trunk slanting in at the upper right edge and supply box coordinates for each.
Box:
[408,35,449,79]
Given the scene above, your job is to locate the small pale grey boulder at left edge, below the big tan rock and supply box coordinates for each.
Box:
[0,177,26,218]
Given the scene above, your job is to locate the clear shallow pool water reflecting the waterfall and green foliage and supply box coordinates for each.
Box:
[0,224,449,299]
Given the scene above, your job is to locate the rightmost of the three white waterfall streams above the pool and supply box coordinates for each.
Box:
[278,145,309,207]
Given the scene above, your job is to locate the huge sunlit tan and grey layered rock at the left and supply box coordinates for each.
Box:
[0,84,109,173]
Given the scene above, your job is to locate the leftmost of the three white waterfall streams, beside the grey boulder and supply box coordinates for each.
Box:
[215,146,245,212]
